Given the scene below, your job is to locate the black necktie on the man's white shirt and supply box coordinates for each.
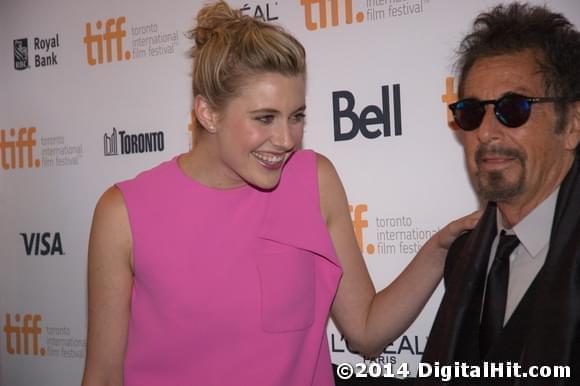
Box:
[479,230,520,358]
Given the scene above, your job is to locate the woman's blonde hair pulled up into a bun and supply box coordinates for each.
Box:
[190,1,306,127]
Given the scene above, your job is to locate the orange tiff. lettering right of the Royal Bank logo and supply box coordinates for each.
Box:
[83,16,131,66]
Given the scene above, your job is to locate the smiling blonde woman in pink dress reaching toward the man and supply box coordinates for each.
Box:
[83,1,474,386]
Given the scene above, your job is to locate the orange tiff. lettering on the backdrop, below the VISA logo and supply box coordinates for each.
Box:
[4,314,46,356]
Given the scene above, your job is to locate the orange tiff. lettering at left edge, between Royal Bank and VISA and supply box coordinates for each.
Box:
[0,127,40,170]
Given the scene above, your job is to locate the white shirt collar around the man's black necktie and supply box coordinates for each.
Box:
[497,187,560,257]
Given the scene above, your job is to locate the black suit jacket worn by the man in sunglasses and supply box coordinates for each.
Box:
[417,152,580,386]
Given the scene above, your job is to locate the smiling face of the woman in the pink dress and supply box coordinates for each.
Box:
[210,73,306,189]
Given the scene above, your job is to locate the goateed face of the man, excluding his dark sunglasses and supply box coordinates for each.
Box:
[463,51,573,207]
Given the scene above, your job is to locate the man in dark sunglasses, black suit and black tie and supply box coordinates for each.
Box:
[418,4,580,385]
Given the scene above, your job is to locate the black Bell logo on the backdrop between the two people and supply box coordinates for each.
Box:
[332,84,403,141]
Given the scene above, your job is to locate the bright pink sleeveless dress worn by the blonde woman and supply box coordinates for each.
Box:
[117,151,341,386]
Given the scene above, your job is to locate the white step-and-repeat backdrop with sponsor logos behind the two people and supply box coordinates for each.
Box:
[0,0,580,386]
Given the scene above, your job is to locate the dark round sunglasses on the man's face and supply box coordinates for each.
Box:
[449,93,580,131]
